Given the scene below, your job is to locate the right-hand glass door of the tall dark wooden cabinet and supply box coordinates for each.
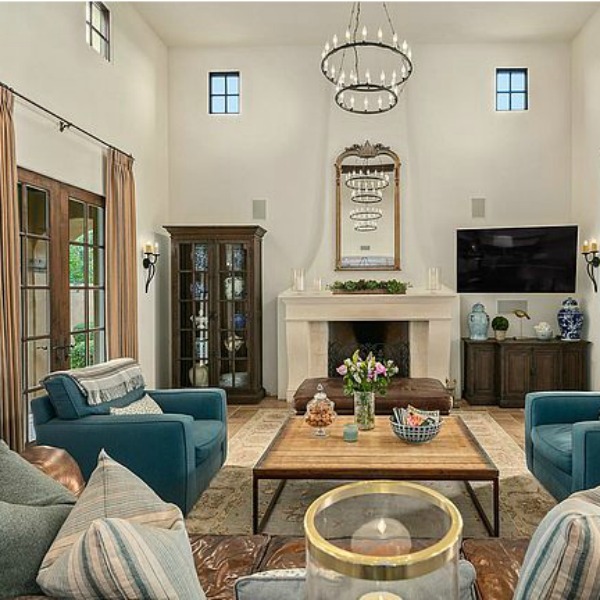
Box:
[217,243,252,388]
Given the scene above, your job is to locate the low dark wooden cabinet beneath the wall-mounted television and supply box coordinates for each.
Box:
[463,338,590,408]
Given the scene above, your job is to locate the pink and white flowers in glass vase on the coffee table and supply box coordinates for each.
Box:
[336,350,398,430]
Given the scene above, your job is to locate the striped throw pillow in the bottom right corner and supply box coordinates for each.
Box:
[514,487,600,600]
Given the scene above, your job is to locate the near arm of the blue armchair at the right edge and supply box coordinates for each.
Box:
[573,419,600,491]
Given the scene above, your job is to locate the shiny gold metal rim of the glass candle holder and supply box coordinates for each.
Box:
[304,481,463,581]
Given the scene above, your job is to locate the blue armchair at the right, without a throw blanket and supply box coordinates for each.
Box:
[525,392,600,500]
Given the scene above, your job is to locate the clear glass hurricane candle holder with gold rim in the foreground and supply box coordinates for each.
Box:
[304,481,462,600]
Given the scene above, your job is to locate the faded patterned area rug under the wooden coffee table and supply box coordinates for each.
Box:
[186,409,555,537]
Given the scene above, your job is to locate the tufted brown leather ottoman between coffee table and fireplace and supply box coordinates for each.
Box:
[294,377,452,415]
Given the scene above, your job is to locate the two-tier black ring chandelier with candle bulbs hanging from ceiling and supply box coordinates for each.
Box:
[321,2,413,114]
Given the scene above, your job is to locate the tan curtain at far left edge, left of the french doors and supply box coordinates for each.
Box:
[0,88,25,452]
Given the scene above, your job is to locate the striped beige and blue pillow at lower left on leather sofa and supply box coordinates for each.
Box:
[37,451,206,600]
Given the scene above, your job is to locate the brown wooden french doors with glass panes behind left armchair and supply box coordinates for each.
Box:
[18,169,106,440]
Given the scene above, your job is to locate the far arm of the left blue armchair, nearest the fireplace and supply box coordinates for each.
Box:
[147,388,227,423]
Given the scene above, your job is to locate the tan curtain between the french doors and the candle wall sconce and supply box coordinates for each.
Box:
[106,148,138,360]
